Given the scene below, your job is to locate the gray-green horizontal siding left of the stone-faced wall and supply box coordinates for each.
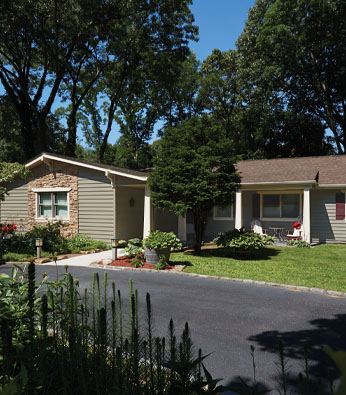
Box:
[0,181,28,227]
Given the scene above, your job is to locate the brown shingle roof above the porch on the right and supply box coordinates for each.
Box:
[236,155,346,185]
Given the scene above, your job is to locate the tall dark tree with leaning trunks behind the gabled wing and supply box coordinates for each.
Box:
[0,0,197,161]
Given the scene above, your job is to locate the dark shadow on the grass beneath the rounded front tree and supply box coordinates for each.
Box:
[184,247,281,261]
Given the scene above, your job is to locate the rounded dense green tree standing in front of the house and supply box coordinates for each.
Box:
[149,115,239,253]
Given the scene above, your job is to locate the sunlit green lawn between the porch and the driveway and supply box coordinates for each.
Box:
[170,245,346,292]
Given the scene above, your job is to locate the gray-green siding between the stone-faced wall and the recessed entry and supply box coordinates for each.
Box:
[78,168,115,243]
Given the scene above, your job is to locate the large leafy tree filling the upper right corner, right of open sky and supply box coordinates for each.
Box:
[237,0,346,154]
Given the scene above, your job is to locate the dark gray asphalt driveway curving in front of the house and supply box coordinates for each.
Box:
[0,265,346,388]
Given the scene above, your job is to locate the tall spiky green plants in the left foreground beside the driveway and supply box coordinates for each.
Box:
[0,264,222,395]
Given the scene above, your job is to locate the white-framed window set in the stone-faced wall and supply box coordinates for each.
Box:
[34,188,70,220]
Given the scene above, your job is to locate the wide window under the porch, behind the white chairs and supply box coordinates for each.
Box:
[261,193,301,218]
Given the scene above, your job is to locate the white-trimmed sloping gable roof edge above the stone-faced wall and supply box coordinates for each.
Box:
[25,152,148,181]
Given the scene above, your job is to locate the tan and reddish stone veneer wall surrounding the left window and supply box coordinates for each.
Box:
[28,162,78,237]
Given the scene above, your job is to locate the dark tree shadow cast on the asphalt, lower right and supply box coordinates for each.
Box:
[249,314,346,393]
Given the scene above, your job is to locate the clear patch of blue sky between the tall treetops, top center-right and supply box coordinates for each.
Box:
[190,0,255,61]
